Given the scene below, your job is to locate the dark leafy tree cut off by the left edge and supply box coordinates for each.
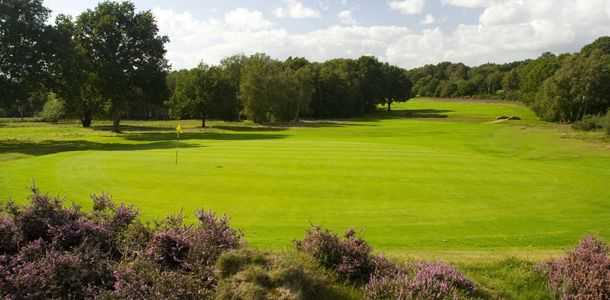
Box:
[0,0,53,117]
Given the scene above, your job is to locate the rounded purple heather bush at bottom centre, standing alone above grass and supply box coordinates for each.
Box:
[295,226,375,283]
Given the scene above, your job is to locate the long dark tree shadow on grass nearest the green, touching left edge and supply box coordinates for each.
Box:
[0,140,201,156]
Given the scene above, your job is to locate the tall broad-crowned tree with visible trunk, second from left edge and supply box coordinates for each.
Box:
[76,1,169,132]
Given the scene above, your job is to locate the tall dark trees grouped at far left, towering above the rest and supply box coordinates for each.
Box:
[0,0,169,131]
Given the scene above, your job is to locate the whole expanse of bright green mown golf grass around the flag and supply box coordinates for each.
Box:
[0,99,610,253]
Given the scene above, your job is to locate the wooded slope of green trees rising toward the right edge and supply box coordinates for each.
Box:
[408,37,610,122]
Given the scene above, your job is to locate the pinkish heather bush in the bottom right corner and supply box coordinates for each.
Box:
[547,237,610,299]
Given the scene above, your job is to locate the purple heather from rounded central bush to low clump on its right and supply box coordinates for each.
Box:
[295,226,476,300]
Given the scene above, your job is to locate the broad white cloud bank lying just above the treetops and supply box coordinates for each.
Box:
[154,0,610,68]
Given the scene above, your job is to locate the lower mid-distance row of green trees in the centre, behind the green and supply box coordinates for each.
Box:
[167,54,411,127]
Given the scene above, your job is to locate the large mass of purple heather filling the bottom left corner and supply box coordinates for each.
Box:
[0,189,242,299]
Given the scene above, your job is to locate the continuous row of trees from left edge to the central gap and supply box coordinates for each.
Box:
[0,0,411,131]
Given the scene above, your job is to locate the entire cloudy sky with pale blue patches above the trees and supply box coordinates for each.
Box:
[44,0,610,68]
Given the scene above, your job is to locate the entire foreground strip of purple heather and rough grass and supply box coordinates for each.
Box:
[0,188,610,300]
